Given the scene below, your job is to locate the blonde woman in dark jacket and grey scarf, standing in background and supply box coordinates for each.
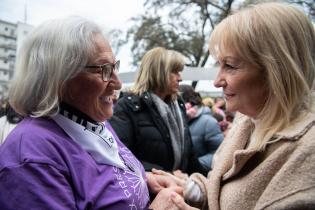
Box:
[110,47,199,176]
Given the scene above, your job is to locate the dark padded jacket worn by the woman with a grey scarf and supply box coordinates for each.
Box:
[109,92,203,174]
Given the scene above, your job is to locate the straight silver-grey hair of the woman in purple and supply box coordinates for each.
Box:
[9,17,101,117]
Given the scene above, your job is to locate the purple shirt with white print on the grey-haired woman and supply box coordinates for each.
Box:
[0,118,149,210]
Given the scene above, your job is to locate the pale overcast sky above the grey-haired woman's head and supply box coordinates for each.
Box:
[0,0,144,72]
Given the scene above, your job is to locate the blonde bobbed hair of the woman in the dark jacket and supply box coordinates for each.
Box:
[131,47,185,99]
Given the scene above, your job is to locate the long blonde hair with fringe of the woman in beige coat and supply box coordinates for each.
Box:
[210,3,315,150]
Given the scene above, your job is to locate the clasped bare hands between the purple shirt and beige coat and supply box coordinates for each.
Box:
[146,169,196,210]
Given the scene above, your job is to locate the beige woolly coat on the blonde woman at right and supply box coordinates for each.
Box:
[192,110,315,210]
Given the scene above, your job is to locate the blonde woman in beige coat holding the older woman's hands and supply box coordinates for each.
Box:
[151,3,315,210]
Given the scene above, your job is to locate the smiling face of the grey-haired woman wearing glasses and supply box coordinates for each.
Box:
[63,35,121,122]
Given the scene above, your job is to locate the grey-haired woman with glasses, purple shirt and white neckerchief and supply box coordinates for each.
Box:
[0,17,177,210]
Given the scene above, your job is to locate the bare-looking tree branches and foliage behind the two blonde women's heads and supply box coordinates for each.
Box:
[117,0,315,66]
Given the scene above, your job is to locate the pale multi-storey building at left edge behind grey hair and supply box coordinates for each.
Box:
[0,20,33,103]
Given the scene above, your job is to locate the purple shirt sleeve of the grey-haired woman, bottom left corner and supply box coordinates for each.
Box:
[0,163,77,210]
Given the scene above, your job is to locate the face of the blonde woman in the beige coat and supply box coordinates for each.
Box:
[214,54,268,118]
